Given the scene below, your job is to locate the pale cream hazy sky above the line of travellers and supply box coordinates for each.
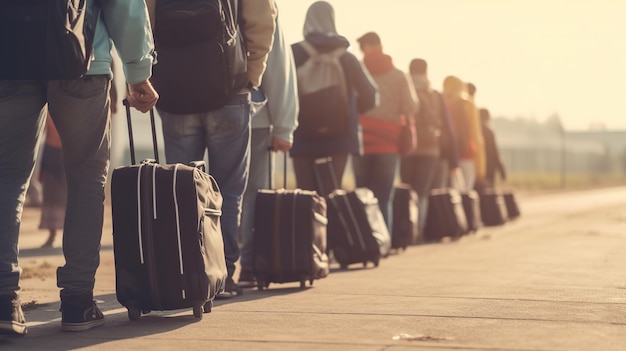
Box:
[276,0,626,130]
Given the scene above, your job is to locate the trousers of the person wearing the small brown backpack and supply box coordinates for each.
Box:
[400,155,439,233]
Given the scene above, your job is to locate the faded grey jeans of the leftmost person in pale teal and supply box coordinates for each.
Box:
[0,76,111,297]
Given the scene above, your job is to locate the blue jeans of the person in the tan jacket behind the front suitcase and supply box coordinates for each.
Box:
[158,93,250,278]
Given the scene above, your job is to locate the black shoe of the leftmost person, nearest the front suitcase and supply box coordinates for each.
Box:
[61,295,104,331]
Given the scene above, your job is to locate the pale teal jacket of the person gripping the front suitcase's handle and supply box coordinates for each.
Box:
[87,0,154,84]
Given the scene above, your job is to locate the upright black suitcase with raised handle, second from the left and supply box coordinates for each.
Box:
[253,154,330,290]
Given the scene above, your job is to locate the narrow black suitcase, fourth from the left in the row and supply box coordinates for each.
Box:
[391,184,418,249]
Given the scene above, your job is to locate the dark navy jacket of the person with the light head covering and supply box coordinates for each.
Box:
[290,32,378,157]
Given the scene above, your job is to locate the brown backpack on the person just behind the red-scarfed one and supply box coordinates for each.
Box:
[415,89,441,150]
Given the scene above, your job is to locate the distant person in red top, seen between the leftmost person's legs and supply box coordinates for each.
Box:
[39,113,67,249]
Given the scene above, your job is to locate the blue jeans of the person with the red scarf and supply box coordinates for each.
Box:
[352,154,399,233]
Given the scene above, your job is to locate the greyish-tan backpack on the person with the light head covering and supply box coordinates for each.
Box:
[295,41,350,139]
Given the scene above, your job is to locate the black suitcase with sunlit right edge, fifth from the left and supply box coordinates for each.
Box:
[424,188,467,242]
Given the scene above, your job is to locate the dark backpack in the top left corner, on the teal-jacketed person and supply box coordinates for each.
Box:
[0,0,100,80]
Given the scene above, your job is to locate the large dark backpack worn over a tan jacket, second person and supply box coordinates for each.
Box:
[152,0,248,114]
